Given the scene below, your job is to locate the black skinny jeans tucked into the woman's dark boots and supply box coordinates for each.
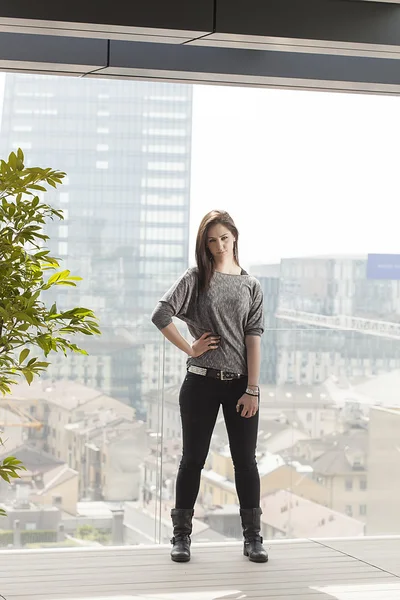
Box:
[175,373,260,509]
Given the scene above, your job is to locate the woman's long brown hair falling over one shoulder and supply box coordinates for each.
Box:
[196,210,239,292]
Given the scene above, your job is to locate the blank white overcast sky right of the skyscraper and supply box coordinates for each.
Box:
[0,74,400,267]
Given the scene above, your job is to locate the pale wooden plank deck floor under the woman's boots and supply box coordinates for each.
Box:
[0,538,400,600]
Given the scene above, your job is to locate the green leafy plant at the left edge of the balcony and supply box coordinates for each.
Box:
[0,149,100,496]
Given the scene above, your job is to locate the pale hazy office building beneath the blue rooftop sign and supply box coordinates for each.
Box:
[277,256,400,384]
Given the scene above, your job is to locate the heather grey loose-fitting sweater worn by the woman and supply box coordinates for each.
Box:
[152,267,264,375]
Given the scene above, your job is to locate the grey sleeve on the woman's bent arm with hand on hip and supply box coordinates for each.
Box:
[151,269,195,330]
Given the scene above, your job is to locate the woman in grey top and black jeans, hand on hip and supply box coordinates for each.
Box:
[152,210,268,562]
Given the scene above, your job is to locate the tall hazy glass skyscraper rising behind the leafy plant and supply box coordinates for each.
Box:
[0,74,192,408]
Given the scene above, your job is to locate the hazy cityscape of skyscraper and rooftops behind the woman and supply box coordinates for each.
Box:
[0,74,400,548]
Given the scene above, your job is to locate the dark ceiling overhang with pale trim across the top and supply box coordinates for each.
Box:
[0,0,400,94]
